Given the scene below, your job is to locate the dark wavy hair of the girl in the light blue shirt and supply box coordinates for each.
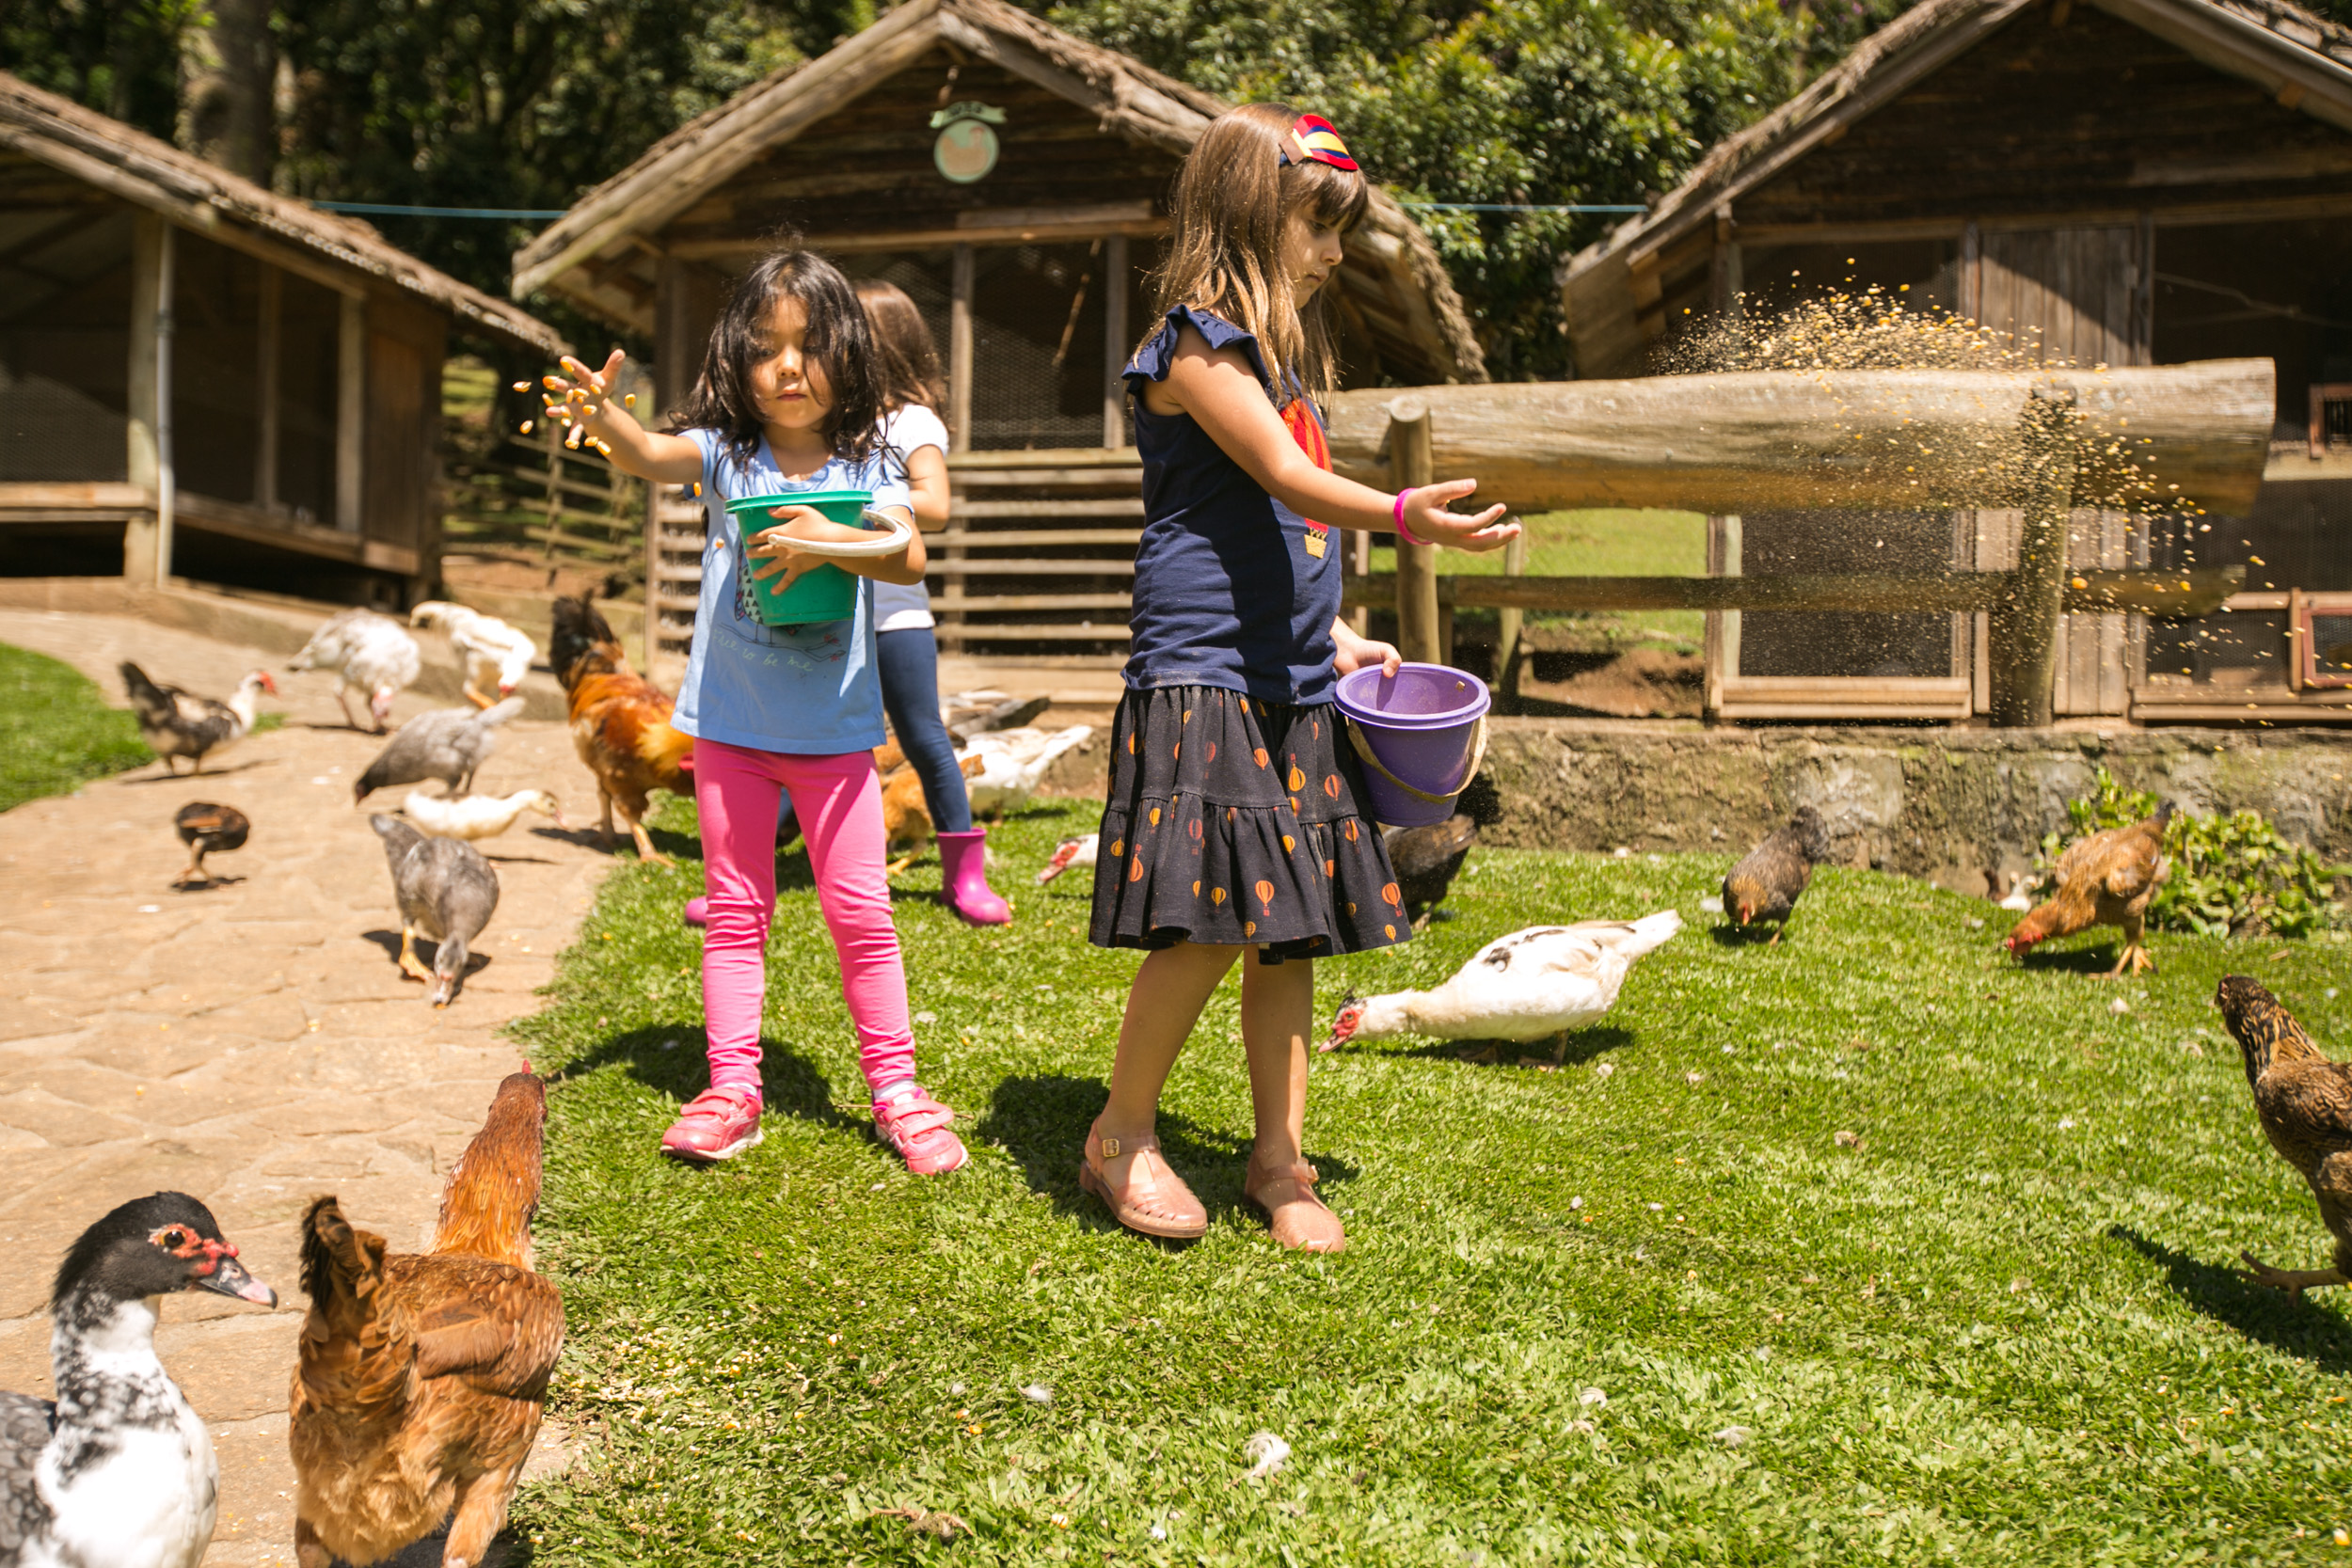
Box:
[671,246,882,463]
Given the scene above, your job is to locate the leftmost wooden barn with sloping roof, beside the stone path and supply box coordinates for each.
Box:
[0,75,564,604]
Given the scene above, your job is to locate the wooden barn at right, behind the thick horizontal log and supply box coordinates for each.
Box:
[1562,0,2352,721]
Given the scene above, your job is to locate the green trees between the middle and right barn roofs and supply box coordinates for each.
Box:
[1049,0,1835,381]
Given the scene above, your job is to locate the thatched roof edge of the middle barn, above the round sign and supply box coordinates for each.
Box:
[516,0,1486,381]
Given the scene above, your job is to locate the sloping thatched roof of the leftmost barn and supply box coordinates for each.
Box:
[0,71,569,355]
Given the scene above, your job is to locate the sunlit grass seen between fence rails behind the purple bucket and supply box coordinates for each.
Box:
[1372,510,1708,649]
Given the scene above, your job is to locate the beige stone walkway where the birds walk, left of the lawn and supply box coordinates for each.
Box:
[0,609,612,1568]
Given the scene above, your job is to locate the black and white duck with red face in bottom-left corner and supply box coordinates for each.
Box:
[0,1192,278,1568]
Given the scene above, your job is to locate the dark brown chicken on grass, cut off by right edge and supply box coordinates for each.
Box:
[2214,975,2352,1295]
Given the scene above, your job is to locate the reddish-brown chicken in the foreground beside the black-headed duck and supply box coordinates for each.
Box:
[290,1069,564,1568]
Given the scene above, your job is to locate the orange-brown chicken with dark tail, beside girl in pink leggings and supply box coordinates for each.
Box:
[548,594,694,865]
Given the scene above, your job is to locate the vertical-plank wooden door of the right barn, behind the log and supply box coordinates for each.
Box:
[1962,216,2154,715]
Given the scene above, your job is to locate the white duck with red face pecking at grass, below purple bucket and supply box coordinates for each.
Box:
[1322,910,1682,1055]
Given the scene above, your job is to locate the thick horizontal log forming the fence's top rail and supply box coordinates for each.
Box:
[1331,359,2277,517]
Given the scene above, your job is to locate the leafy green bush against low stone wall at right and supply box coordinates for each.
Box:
[2040,767,2352,936]
